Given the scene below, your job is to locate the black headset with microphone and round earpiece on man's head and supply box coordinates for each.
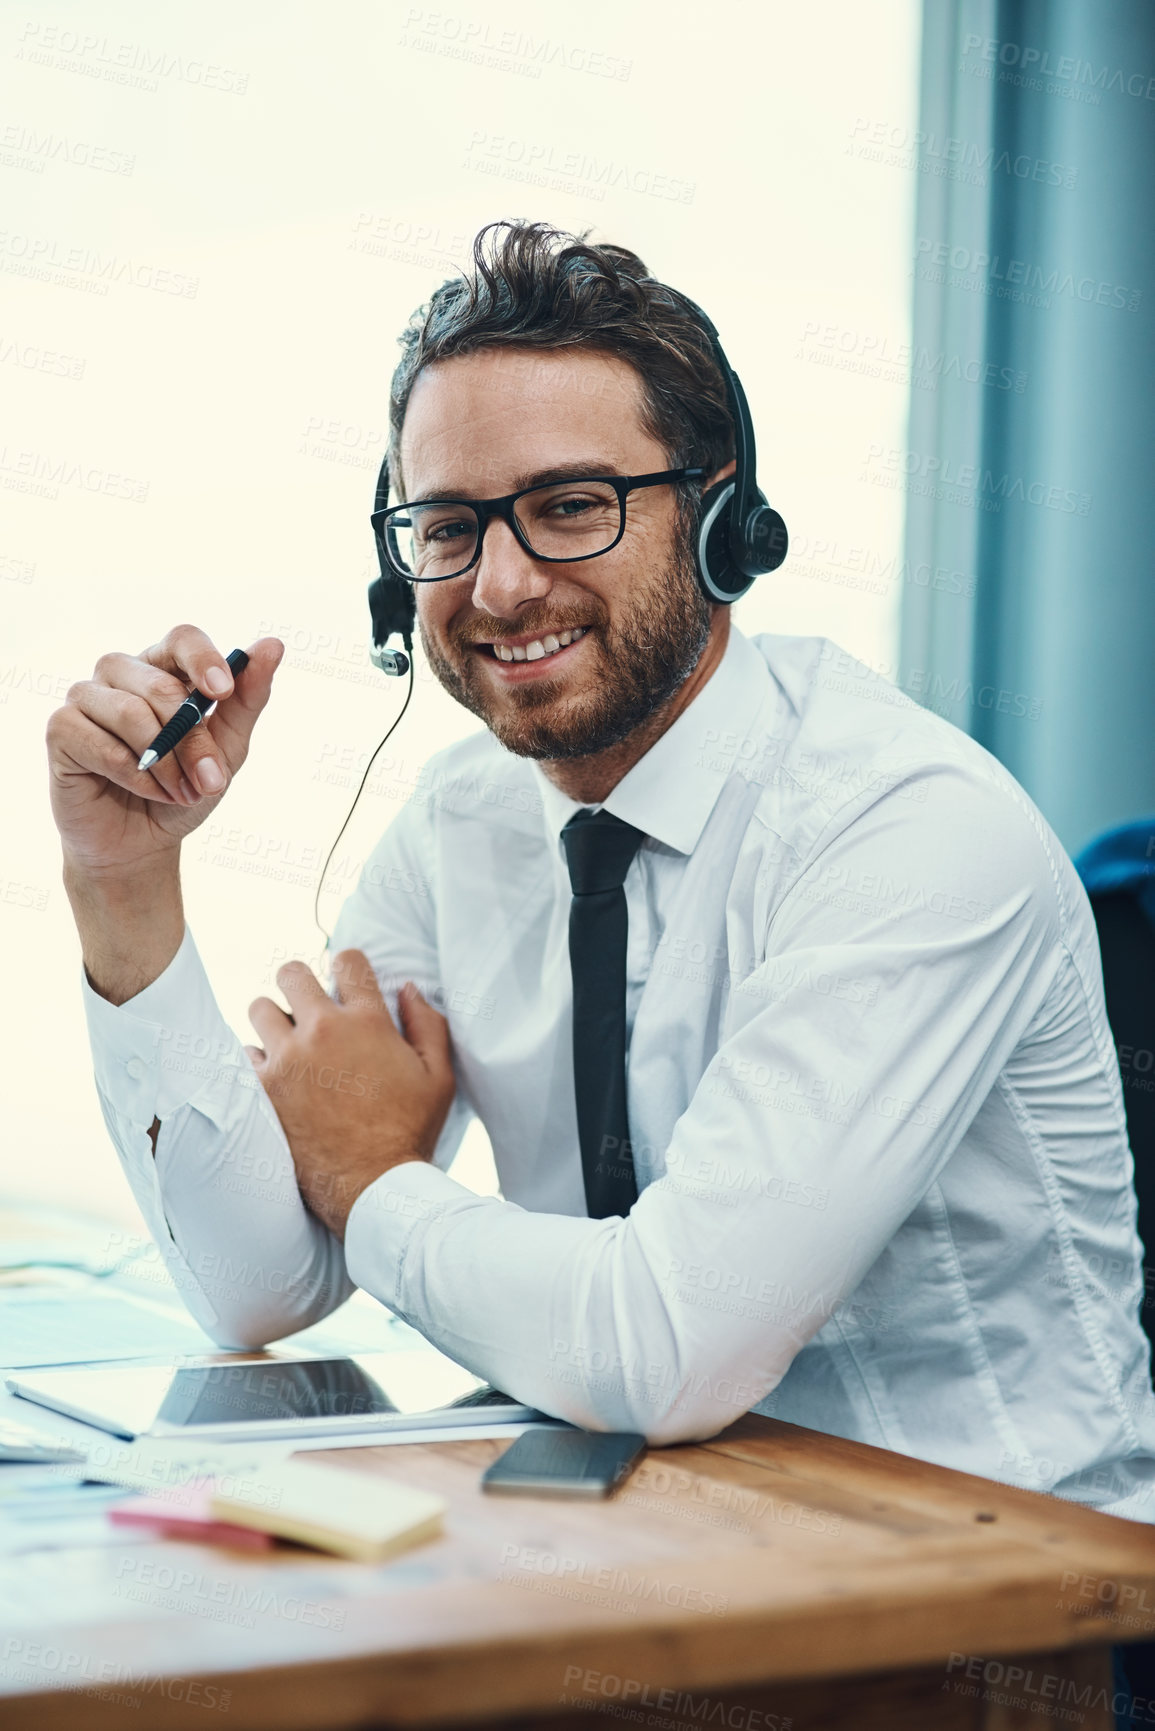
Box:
[369,290,788,675]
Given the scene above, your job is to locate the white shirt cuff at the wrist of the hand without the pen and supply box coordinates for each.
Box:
[345,1160,477,1316]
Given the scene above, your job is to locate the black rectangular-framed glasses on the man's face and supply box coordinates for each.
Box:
[369,469,707,583]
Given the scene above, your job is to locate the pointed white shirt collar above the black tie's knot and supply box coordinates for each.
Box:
[532,620,771,853]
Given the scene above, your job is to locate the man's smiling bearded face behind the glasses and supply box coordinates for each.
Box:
[406,348,734,778]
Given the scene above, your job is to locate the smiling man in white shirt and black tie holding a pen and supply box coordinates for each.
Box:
[50,212,1155,1520]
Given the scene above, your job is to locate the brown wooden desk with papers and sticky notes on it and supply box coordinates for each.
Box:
[0,1418,1155,1731]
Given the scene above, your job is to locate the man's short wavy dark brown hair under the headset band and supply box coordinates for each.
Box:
[390,220,734,505]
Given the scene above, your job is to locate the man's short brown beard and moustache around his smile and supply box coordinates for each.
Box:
[419,531,710,758]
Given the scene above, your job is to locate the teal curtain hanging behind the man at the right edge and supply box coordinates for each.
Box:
[900,0,1155,853]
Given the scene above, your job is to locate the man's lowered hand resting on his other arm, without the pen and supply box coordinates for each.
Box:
[246,950,455,1239]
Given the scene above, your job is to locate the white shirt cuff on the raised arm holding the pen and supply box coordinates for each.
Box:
[81,926,256,1129]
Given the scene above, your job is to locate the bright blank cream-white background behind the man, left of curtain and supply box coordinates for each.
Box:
[0,0,918,1220]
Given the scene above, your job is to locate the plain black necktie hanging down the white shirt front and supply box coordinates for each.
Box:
[561,810,646,1220]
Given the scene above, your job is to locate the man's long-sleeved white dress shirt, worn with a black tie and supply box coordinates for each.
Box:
[85,627,1155,1520]
